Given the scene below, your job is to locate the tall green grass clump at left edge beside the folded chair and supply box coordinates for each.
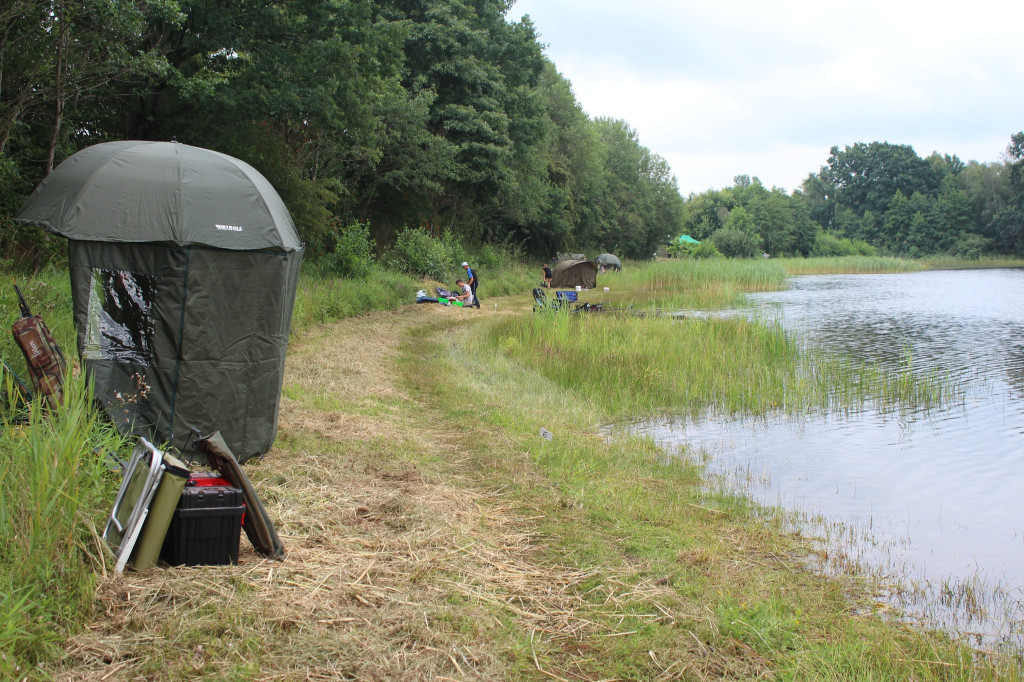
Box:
[0,378,123,679]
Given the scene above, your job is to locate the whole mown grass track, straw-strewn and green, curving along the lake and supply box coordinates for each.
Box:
[45,300,1007,680]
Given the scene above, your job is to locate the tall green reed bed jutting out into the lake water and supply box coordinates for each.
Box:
[487,311,958,417]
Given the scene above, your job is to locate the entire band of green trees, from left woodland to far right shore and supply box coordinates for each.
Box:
[0,0,1024,266]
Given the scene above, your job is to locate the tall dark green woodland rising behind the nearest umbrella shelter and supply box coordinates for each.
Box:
[0,0,683,258]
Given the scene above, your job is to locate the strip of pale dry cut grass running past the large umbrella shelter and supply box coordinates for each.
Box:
[48,306,622,680]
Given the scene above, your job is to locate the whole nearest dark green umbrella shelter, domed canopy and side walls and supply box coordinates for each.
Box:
[16,141,303,461]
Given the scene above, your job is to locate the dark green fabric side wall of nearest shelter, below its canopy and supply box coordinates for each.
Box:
[70,236,300,461]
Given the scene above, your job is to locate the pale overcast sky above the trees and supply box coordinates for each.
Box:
[508,0,1024,196]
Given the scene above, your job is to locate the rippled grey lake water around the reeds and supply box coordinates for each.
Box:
[639,269,1024,647]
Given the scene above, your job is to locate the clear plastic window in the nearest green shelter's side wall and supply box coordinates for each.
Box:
[82,268,157,365]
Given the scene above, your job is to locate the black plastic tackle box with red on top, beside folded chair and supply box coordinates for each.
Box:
[160,483,246,566]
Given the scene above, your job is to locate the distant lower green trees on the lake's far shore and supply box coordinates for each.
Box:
[683,133,1024,258]
